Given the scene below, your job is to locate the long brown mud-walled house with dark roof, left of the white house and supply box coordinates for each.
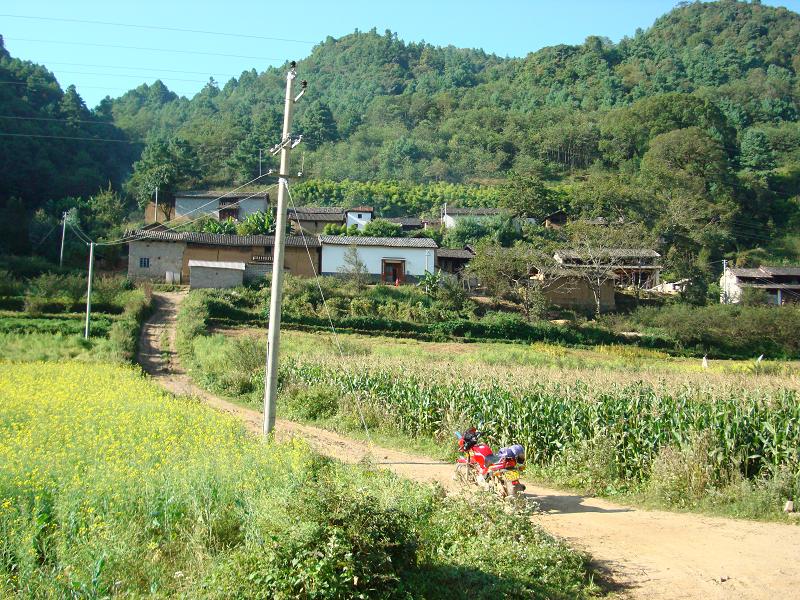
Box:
[126,229,320,287]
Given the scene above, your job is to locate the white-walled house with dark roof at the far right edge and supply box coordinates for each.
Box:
[719,266,800,306]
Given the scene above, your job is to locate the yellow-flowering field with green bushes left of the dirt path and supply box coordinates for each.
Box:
[0,362,598,598]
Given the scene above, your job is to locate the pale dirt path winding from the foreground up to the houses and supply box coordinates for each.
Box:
[139,294,800,600]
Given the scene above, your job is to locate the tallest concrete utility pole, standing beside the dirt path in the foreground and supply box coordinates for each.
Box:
[264,61,306,435]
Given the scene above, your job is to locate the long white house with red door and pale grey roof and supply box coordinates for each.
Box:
[319,235,437,283]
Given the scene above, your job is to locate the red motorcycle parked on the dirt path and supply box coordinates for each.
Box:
[455,427,525,498]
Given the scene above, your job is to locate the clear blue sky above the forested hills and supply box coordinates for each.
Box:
[0,0,800,107]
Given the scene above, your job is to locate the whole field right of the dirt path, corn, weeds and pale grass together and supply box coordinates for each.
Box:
[190,316,800,520]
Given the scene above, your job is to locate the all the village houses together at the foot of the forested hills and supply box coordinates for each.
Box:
[128,191,800,310]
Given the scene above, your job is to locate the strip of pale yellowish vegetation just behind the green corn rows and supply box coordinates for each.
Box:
[218,329,800,390]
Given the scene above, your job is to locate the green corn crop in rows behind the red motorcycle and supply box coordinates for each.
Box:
[282,363,800,480]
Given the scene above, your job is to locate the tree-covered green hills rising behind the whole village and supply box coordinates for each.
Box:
[0,0,800,270]
